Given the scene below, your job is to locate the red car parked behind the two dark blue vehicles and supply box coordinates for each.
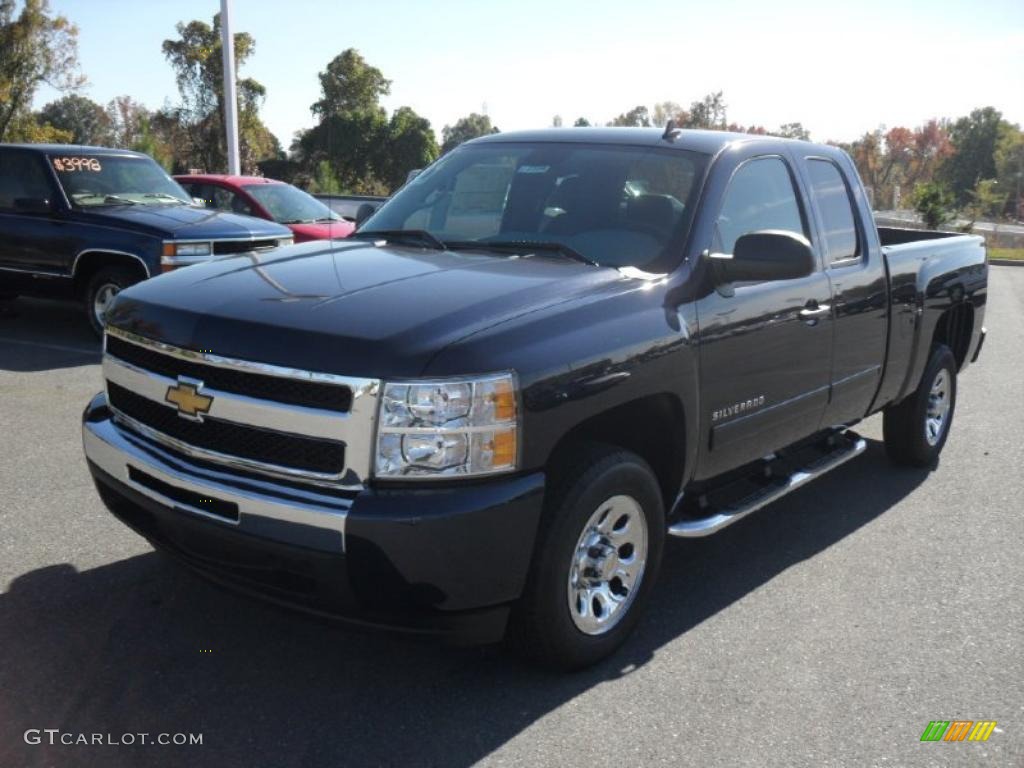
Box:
[174,174,355,243]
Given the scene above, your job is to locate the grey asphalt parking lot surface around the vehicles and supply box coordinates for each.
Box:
[0,267,1024,768]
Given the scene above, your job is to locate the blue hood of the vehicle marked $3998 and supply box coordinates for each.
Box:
[80,205,290,240]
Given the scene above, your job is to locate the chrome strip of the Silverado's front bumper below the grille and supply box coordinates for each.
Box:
[82,394,353,553]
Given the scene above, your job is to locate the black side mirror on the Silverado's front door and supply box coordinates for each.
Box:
[710,229,814,283]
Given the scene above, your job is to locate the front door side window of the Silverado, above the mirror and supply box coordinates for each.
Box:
[716,158,807,253]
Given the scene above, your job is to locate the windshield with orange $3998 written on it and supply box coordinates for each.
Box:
[50,154,191,207]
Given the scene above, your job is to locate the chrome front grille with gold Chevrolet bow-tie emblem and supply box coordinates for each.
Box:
[103,328,380,489]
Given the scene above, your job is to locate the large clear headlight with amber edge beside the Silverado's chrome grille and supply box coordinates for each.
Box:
[375,374,519,479]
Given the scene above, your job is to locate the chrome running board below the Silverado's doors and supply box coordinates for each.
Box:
[668,432,867,539]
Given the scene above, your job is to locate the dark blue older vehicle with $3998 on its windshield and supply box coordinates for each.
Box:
[0,144,292,334]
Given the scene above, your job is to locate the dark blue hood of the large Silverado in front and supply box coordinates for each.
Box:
[108,241,626,378]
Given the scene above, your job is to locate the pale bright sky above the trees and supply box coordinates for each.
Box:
[37,0,1024,146]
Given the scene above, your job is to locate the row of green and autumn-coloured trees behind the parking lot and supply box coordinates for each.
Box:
[0,0,1024,217]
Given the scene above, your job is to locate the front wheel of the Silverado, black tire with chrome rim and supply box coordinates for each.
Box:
[509,445,665,670]
